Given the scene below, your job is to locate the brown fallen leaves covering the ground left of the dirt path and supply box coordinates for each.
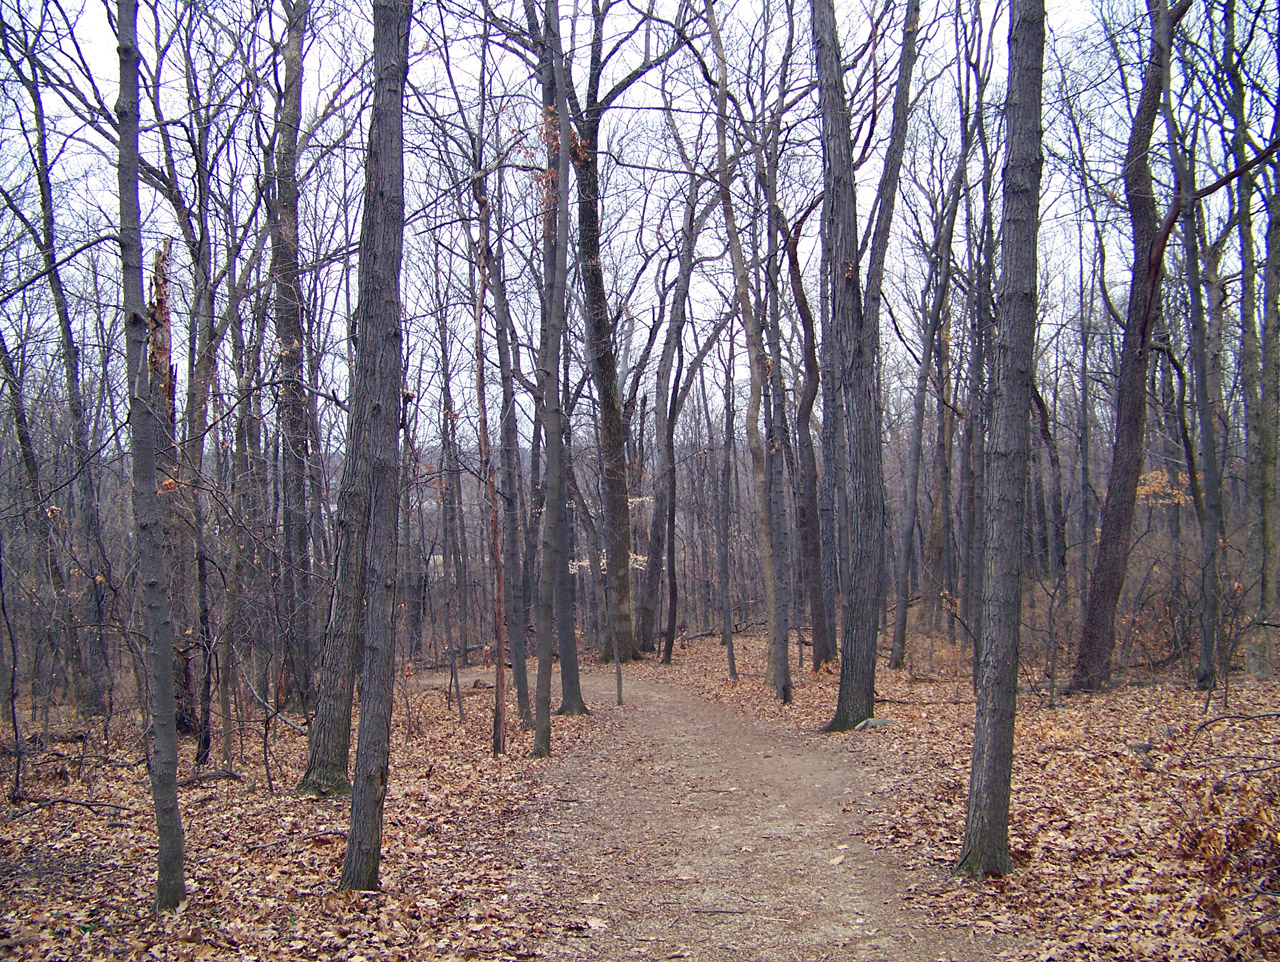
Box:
[0,678,588,962]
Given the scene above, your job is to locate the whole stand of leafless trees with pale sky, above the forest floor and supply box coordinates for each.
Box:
[0,0,1280,945]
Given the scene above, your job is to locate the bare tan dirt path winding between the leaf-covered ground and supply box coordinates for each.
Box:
[513,673,1012,962]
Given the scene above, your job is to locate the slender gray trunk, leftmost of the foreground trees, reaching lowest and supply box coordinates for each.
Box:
[115,0,186,912]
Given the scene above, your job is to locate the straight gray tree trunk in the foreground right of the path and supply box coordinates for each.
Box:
[956,0,1044,878]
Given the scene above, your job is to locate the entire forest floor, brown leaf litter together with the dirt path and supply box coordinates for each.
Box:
[0,637,1280,962]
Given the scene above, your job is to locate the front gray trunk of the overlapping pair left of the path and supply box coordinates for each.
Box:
[339,0,412,892]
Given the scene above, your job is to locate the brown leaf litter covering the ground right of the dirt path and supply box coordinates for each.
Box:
[640,636,1280,962]
